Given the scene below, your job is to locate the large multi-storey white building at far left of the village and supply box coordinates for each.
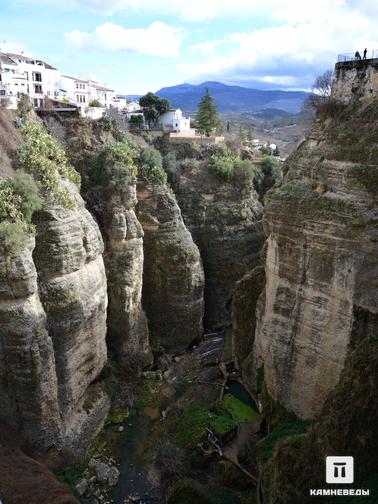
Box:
[0,53,60,108]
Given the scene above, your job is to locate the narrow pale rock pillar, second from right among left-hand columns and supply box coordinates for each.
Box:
[103,179,152,368]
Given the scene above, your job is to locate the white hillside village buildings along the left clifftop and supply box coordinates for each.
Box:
[0,51,277,153]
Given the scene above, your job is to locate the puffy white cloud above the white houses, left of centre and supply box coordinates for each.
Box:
[64,21,184,57]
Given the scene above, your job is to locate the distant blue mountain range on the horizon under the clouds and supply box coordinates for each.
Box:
[152,82,307,114]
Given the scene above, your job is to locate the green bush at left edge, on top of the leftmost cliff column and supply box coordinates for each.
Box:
[0,170,42,251]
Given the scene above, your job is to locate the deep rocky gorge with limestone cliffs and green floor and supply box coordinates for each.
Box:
[0,59,378,504]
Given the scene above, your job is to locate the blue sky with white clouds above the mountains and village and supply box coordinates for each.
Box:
[0,0,378,94]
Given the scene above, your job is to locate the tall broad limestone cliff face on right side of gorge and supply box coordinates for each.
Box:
[248,102,378,418]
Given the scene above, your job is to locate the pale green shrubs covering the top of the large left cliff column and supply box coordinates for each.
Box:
[16,123,80,208]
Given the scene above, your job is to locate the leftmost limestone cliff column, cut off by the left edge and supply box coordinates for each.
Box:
[0,239,62,448]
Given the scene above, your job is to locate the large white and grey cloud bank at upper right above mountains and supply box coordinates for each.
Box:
[178,0,378,87]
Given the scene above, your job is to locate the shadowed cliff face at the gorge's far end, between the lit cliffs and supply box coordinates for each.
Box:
[174,164,264,329]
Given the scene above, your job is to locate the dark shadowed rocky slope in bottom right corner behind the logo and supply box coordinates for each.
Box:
[261,330,378,504]
